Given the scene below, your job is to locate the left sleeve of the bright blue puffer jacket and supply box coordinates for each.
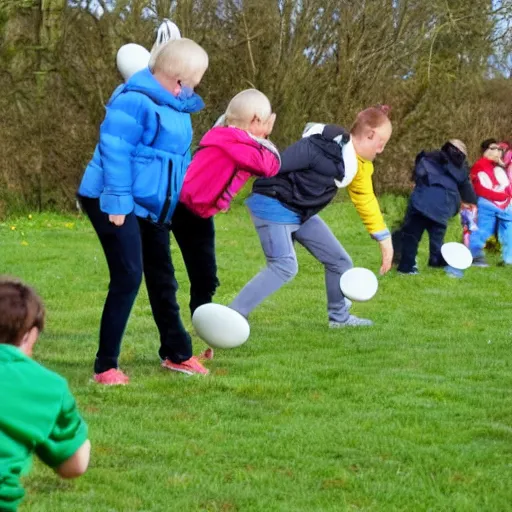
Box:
[99,93,145,215]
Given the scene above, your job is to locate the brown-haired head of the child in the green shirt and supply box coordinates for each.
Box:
[0,276,45,345]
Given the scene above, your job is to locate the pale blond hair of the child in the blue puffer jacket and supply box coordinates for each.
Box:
[149,38,208,83]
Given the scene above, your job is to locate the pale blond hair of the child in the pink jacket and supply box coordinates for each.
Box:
[224,89,272,128]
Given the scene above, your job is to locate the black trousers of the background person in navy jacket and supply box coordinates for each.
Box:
[393,206,446,272]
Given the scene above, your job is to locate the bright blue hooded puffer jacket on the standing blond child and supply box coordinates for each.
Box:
[78,68,204,223]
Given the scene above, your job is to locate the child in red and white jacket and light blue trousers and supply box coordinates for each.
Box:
[469,139,512,267]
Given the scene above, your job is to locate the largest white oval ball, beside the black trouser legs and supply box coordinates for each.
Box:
[192,302,251,348]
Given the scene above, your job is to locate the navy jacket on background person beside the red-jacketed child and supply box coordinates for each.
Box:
[410,151,477,225]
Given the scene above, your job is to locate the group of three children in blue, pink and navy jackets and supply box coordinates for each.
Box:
[78,22,393,385]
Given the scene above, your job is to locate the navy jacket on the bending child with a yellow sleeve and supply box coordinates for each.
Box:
[252,132,348,222]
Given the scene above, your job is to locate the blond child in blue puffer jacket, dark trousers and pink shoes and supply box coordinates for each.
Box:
[78,39,212,385]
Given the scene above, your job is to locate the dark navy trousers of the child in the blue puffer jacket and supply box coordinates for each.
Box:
[79,197,192,373]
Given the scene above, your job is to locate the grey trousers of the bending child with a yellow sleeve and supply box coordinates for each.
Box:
[229,215,353,322]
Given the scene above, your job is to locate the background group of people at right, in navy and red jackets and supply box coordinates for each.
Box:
[393,139,512,277]
